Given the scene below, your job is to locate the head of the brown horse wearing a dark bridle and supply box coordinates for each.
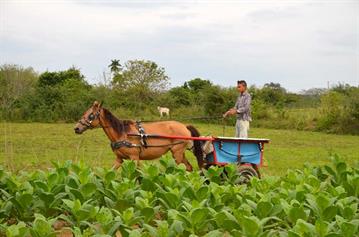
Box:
[74,101,102,134]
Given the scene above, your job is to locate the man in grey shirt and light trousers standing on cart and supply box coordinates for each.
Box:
[223,80,252,138]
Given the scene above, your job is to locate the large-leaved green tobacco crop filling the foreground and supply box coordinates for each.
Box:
[0,157,359,237]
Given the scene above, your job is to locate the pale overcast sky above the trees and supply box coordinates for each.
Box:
[0,0,359,92]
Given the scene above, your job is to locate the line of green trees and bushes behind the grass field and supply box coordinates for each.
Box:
[0,59,359,134]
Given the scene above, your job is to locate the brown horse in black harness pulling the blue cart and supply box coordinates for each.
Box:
[74,101,203,171]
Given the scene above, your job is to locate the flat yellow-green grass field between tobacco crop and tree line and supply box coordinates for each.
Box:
[0,123,359,175]
